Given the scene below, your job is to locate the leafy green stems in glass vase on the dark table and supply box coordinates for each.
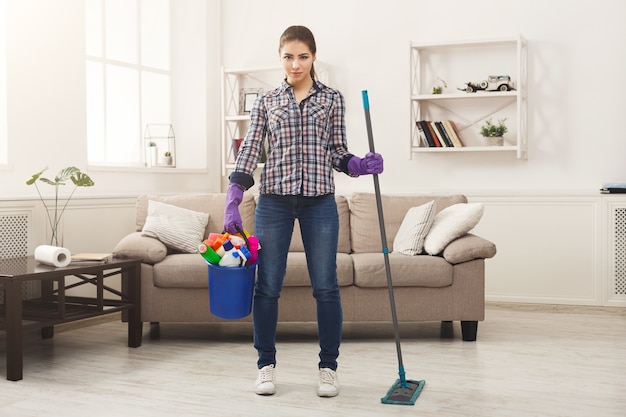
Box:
[26,167,94,246]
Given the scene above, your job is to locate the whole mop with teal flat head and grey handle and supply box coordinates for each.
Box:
[362,90,426,405]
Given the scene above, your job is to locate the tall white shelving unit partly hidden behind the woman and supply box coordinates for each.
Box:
[221,61,330,176]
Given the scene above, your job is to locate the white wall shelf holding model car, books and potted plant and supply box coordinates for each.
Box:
[410,35,528,159]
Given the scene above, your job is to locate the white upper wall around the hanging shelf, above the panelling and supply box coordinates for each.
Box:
[222,0,626,193]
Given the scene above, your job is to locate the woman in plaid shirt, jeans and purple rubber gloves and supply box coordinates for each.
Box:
[224,26,383,397]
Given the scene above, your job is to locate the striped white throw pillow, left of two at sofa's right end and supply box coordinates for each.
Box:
[393,200,435,256]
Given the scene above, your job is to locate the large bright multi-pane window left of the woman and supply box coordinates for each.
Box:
[85,0,171,166]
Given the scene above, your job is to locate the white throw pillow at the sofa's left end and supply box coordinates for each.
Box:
[141,200,209,253]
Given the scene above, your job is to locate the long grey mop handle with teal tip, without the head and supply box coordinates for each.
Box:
[361,90,406,380]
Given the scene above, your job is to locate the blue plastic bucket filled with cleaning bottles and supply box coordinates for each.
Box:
[207,262,256,320]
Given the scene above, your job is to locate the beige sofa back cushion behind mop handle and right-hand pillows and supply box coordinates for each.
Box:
[350,193,467,253]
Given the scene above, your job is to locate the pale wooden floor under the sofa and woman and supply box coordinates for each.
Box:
[0,305,626,417]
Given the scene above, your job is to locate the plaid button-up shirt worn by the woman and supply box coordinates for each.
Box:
[231,81,352,197]
